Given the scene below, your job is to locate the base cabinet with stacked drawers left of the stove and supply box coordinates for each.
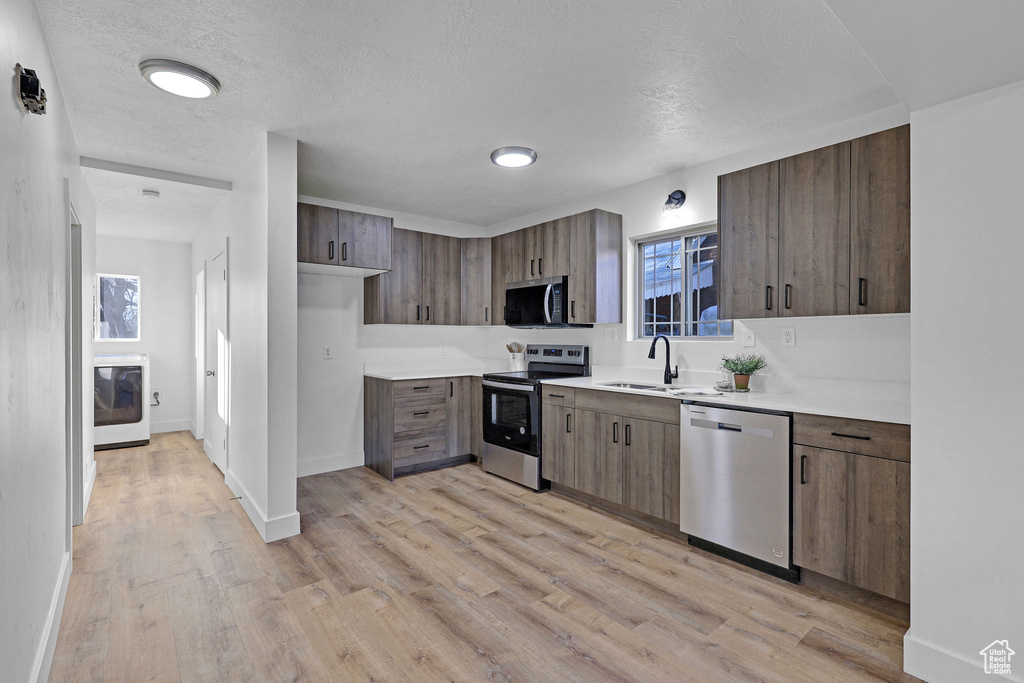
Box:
[362,377,473,480]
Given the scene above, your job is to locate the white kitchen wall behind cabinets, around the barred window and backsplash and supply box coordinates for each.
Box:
[298,106,910,476]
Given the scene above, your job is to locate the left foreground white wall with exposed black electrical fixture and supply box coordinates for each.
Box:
[0,0,94,681]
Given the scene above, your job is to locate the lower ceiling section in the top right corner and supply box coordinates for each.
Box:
[827,0,1024,112]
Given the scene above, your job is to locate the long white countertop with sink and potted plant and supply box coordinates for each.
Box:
[544,377,910,425]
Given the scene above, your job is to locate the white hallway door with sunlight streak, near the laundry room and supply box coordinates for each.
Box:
[203,251,230,471]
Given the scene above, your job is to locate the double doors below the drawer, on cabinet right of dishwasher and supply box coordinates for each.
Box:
[793,445,910,602]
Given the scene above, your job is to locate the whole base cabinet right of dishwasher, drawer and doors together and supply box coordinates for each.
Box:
[793,414,910,602]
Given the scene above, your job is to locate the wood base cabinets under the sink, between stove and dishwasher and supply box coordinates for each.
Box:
[541,386,679,525]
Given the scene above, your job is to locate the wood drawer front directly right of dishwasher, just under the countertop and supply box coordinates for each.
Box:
[793,413,910,463]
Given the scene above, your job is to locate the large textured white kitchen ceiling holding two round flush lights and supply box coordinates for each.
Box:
[37,0,898,225]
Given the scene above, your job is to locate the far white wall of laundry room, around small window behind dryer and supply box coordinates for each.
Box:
[96,235,194,434]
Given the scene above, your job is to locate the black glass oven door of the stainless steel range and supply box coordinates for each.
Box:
[483,380,541,456]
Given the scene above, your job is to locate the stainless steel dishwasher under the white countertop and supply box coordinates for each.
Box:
[679,402,799,581]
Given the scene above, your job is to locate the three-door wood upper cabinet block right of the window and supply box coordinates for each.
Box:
[718,126,910,319]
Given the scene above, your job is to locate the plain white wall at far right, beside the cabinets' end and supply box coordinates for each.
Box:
[904,82,1024,682]
